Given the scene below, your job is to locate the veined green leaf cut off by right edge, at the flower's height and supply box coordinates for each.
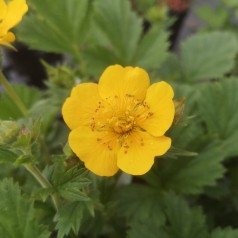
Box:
[199,78,238,156]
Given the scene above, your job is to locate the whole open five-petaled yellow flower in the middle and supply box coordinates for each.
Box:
[62,65,175,176]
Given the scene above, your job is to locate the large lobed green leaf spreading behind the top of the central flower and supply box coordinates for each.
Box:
[18,0,169,77]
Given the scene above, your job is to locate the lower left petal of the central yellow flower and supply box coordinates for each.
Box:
[69,127,118,176]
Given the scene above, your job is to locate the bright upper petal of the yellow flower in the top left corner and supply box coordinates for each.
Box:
[0,0,28,33]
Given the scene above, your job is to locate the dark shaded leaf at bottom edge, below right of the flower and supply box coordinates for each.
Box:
[164,193,207,238]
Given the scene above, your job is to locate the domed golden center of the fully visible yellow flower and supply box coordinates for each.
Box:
[110,112,135,134]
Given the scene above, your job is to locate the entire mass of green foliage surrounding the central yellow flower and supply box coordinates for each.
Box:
[3,0,238,238]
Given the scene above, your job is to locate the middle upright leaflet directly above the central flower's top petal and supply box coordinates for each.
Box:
[94,0,142,64]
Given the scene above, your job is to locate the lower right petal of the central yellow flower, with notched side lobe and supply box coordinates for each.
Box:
[117,131,171,175]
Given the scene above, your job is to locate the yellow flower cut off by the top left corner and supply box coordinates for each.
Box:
[0,0,28,46]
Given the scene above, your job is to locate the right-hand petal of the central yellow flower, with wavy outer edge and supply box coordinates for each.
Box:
[138,81,175,136]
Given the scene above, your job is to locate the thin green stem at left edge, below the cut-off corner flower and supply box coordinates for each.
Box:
[0,72,28,117]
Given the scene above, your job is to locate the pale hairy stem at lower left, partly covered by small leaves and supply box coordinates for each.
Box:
[24,164,59,211]
